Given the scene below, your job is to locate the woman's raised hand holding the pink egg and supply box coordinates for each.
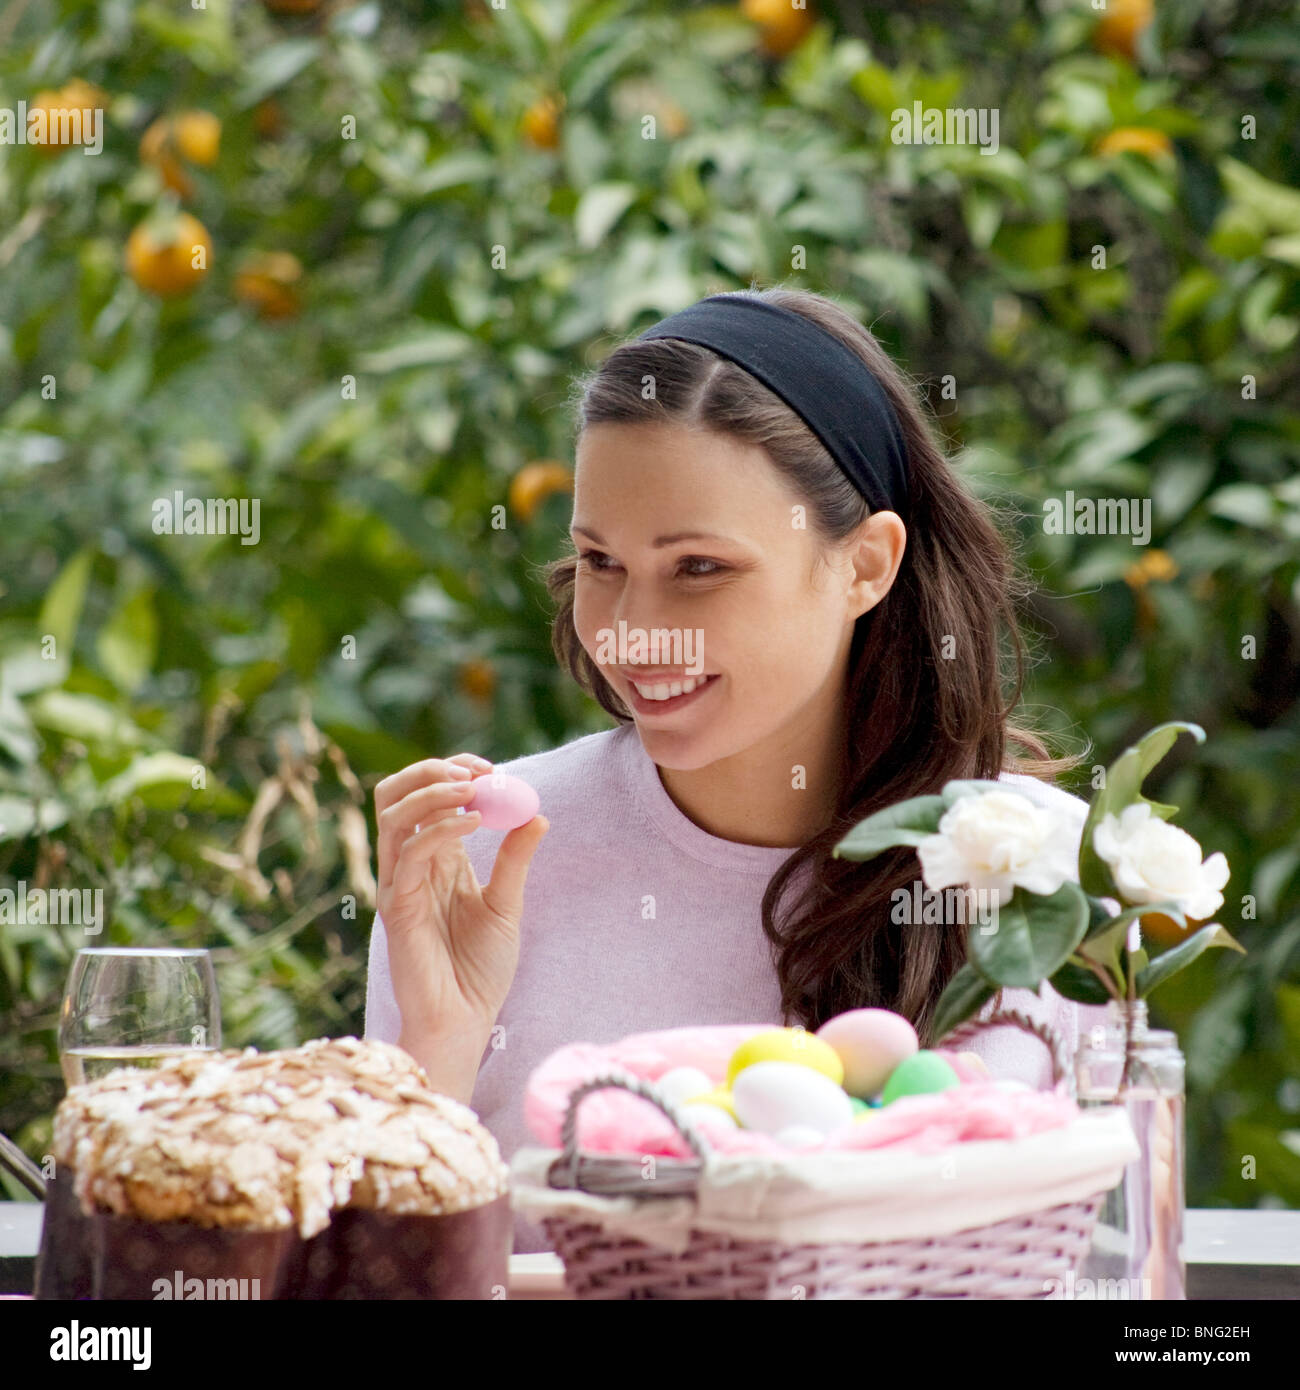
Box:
[374,753,551,1045]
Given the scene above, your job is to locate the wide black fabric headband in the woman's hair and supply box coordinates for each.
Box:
[638,295,908,518]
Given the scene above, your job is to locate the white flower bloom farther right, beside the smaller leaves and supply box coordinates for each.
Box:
[1093,801,1228,922]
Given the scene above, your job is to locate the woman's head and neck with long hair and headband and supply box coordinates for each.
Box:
[548,289,1071,956]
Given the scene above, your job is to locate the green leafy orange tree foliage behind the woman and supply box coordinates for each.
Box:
[0,0,1300,1207]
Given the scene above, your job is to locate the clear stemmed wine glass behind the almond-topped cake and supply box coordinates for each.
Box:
[58,947,221,1086]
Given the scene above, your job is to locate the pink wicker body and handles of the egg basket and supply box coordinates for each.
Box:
[542,1009,1104,1300]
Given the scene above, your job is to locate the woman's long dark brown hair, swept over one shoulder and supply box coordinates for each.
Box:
[542,288,1080,1045]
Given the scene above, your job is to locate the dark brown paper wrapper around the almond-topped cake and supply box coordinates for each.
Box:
[35,1166,513,1300]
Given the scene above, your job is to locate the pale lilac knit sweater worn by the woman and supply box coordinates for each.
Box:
[366,724,1105,1252]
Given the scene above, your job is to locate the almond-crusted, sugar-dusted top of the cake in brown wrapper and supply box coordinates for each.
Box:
[53,1037,509,1240]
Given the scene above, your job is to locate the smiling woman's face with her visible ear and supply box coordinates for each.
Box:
[571,424,904,770]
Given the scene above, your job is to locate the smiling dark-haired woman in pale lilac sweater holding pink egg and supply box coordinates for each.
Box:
[366,289,1104,1251]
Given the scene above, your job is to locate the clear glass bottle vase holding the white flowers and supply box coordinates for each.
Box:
[1075,999,1187,1300]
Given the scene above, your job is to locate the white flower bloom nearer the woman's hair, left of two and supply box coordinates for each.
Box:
[916,791,1082,906]
